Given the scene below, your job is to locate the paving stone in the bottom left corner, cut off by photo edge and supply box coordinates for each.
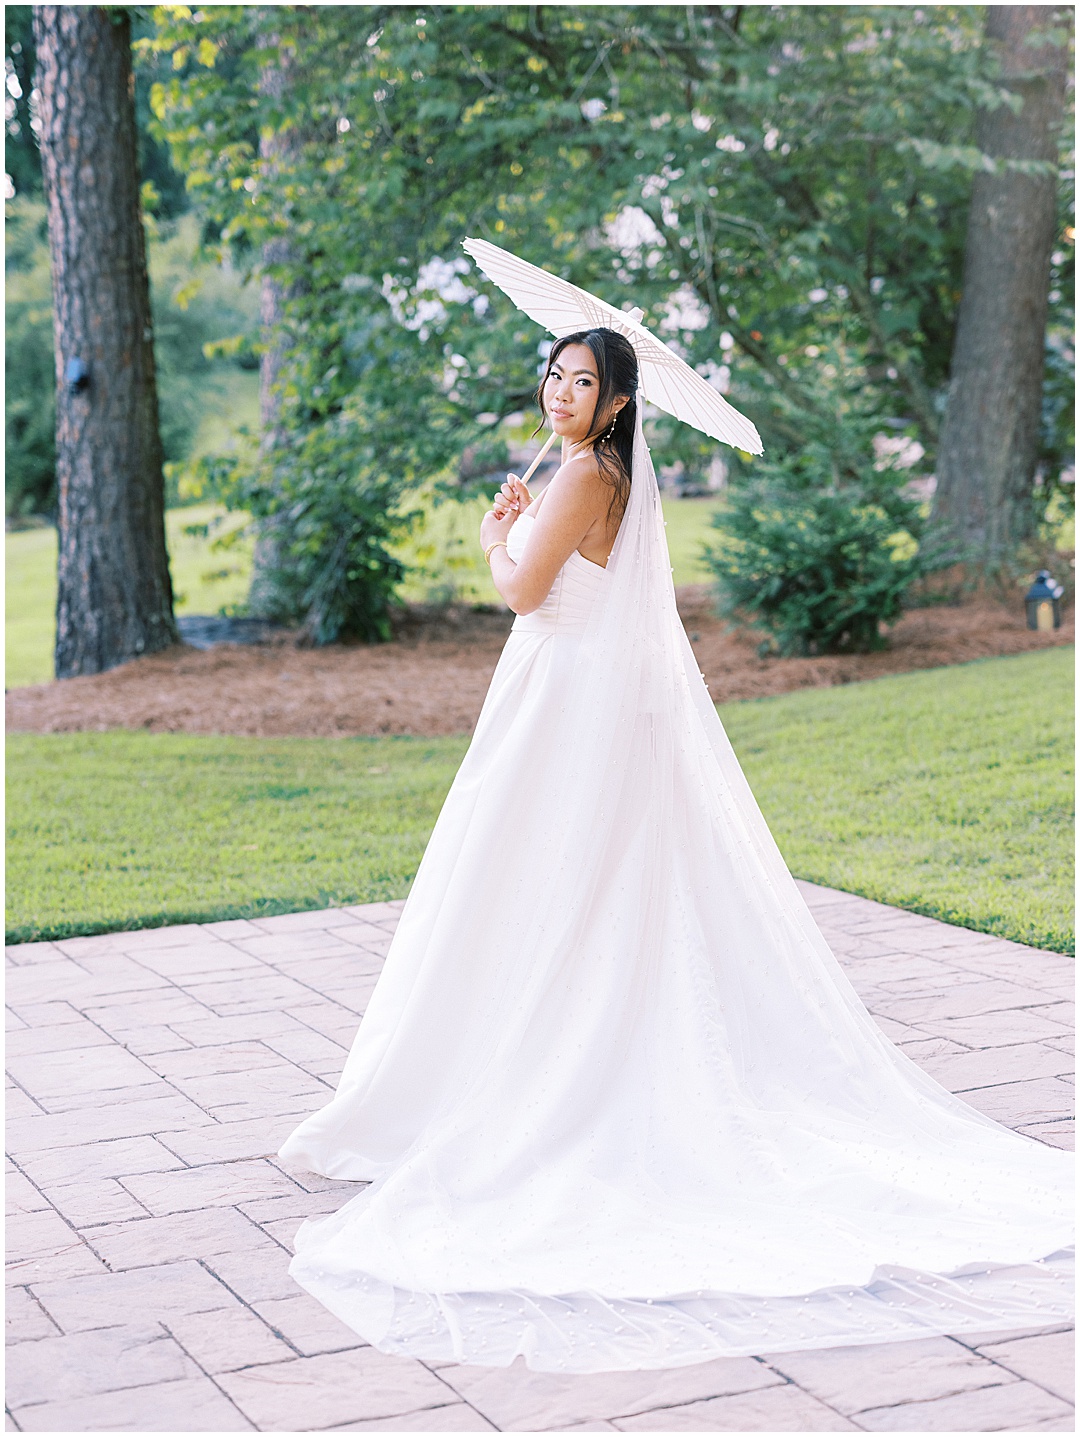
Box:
[14,1377,253,1433]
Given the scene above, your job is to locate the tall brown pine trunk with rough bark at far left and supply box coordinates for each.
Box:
[34,6,177,678]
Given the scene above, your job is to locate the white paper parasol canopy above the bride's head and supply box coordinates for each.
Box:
[462,240,763,454]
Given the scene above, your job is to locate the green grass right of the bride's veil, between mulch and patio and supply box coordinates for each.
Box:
[721,648,1074,953]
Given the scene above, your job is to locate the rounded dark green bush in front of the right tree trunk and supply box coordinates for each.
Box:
[707,440,938,655]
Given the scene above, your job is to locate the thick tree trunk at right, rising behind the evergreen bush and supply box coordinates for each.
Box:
[934,4,1070,569]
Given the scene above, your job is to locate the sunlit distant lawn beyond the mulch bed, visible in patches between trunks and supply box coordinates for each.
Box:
[4,500,715,688]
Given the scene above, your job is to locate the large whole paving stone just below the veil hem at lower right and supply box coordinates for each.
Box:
[765,1338,1005,1420]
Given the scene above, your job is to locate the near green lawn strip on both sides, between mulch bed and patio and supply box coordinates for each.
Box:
[7,650,1073,951]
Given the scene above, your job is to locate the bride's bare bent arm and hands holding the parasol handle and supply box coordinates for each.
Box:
[480,454,610,614]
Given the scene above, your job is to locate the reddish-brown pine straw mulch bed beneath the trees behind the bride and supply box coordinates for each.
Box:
[7,586,1074,737]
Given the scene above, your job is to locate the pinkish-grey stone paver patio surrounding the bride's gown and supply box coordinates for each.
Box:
[7,884,1073,1433]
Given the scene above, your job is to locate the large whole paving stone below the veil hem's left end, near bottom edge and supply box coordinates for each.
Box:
[218,1348,450,1431]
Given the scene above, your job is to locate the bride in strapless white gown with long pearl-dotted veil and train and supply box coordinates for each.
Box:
[281,329,1071,1372]
